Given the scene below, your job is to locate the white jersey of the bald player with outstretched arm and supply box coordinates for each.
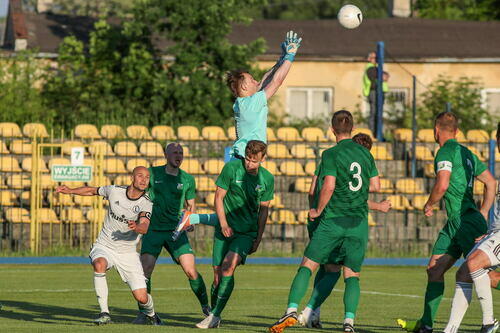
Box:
[95,185,153,253]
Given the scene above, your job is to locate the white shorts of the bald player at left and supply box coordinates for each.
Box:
[89,244,146,290]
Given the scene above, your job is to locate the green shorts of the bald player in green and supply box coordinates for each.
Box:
[141,229,194,264]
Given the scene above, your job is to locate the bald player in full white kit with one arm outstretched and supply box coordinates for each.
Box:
[56,166,162,325]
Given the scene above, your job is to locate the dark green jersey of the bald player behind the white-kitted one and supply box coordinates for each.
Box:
[149,165,196,231]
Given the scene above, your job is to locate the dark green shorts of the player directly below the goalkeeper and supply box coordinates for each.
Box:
[212,229,255,266]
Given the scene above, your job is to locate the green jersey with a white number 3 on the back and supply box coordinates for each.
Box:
[315,139,378,219]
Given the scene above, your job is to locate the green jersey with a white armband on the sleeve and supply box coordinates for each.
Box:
[434,139,486,219]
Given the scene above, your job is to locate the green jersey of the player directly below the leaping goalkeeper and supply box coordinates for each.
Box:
[215,160,274,236]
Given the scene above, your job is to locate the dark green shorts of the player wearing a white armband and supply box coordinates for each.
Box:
[432,210,488,259]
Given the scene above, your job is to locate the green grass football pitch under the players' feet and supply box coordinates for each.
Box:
[0,265,500,333]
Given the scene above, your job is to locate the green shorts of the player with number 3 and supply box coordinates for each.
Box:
[304,217,368,272]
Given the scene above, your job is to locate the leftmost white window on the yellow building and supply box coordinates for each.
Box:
[287,87,333,119]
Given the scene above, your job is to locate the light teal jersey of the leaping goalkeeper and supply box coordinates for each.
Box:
[231,90,269,157]
